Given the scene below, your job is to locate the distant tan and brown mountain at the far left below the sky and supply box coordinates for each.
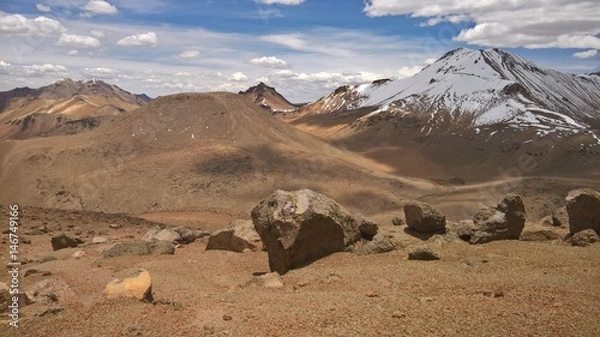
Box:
[0,79,150,138]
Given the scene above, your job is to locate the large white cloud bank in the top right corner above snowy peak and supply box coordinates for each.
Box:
[364,0,600,49]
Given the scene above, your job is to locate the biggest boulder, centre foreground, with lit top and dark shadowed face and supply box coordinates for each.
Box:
[251,189,361,274]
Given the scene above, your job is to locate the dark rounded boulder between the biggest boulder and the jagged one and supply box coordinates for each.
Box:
[404,201,446,233]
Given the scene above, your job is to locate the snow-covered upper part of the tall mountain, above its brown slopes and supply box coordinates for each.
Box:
[300,48,600,140]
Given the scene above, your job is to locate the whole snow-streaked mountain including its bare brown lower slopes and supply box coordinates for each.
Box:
[281,48,600,181]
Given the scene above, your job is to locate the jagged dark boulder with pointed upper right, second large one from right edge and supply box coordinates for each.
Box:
[469,193,525,244]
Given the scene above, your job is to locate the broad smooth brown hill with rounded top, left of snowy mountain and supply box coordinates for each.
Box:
[0,93,441,214]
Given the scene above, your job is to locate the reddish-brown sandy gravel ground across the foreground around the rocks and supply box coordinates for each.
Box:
[0,207,600,337]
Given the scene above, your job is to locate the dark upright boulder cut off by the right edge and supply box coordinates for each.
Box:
[567,188,600,234]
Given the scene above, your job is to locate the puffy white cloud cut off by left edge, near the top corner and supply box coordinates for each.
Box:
[0,11,65,36]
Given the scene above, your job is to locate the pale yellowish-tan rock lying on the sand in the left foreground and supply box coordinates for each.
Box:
[104,269,153,302]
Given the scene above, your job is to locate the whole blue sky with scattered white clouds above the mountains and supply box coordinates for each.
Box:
[0,0,600,102]
